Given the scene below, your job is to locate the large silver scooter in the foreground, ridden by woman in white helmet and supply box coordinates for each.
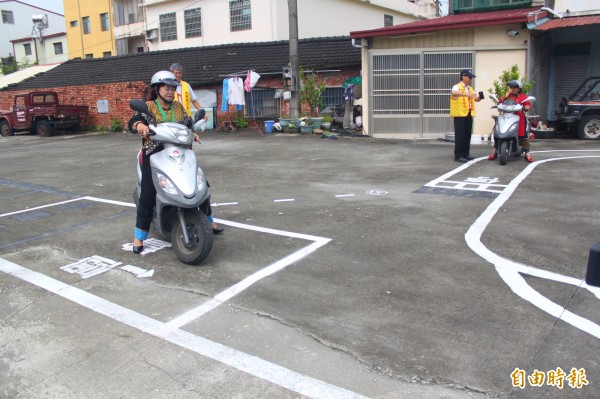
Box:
[129,100,213,265]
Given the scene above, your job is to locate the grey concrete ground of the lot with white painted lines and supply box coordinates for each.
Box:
[0,131,600,399]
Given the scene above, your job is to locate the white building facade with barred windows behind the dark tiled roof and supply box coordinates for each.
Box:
[143,0,421,51]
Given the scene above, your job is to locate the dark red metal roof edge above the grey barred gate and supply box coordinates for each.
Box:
[350,7,547,39]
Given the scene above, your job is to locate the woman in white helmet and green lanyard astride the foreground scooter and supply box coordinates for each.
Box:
[129,71,220,254]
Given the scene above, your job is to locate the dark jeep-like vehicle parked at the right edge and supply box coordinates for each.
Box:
[556,76,600,140]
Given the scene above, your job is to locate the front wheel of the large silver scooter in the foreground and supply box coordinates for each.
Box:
[171,209,213,266]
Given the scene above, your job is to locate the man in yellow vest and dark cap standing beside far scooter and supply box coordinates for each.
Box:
[450,69,481,163]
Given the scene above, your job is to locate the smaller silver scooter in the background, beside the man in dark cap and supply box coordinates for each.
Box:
[489,93,535,165]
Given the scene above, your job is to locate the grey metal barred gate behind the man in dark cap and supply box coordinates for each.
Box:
[370,50,473,138]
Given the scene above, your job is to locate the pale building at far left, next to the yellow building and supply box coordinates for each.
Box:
[0,0,68,64]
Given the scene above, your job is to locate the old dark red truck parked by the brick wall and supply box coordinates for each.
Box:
[0,91,89,137]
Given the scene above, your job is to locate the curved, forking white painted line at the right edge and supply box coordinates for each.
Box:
[465,155,600,338]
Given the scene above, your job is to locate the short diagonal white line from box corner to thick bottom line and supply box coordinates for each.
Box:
[165,238,331,329]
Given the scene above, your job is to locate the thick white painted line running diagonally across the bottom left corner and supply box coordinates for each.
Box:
[0,258,366,399]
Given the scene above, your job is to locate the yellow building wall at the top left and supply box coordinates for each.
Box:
[63,0,116,59]
